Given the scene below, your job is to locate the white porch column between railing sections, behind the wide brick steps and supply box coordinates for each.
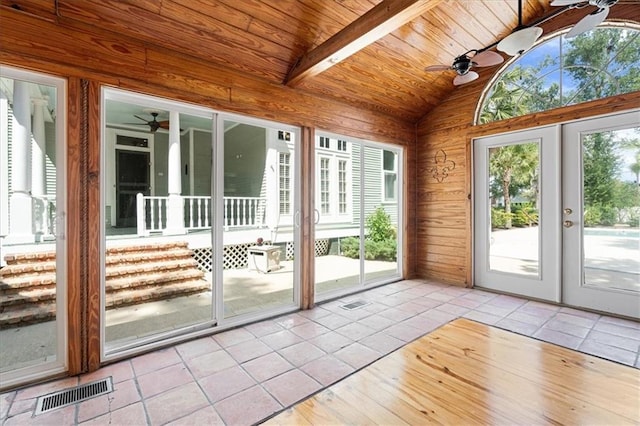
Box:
[164,111,187,235]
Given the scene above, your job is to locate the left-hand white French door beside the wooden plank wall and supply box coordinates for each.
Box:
[473,127,560,301]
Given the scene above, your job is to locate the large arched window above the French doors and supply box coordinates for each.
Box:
[476,24,640,124]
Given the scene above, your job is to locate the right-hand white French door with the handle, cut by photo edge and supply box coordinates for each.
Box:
[563,112,640,317]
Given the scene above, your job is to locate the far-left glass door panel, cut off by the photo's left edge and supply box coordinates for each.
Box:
[0,67,67,389]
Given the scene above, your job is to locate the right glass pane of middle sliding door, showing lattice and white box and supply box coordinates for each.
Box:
[220,120,296,318]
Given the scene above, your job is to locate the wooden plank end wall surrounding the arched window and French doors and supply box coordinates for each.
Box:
[415,4,640,286]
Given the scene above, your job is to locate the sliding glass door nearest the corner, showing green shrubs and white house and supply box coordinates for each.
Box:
[315,132,402,300]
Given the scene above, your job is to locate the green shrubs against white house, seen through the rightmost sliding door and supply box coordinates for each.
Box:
[340,207,398,261]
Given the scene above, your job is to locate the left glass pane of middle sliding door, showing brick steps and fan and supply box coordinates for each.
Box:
[103,91,214,354]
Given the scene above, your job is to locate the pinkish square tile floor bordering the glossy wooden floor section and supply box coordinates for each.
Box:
[0,280,640,425]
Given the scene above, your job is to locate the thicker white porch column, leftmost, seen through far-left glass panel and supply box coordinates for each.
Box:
[6,80,34,243]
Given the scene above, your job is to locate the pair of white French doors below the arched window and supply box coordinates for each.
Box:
[473,111,640,317]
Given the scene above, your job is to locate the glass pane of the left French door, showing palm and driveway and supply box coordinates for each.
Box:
[488,142,540,276]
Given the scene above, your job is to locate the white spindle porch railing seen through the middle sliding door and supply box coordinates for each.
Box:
[136,193,267,236]
